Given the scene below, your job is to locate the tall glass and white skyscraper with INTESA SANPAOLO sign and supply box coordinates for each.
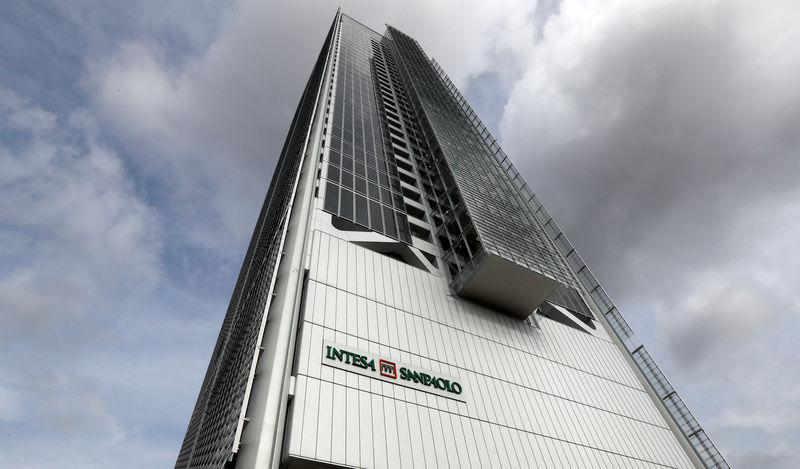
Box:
[176,13,728,468]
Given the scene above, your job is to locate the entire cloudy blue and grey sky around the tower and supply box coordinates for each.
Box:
[0,0,800,469]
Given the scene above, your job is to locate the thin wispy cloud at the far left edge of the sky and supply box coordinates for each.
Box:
[0,89,161,466]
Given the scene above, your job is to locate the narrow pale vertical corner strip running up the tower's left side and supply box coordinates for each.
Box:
[233,10,341,469]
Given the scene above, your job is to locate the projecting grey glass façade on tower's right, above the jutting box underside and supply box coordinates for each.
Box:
[383,23,577,291]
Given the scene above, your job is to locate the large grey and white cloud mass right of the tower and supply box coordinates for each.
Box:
[500,0,800,467]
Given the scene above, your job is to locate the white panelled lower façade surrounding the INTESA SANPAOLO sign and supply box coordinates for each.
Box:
[287,231,692,468]
